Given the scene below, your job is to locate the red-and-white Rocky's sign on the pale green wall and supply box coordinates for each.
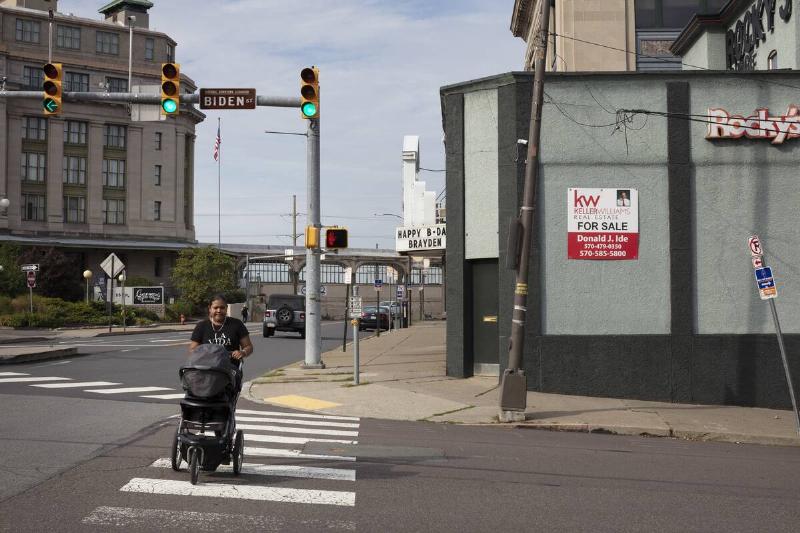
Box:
[706,104,800,144]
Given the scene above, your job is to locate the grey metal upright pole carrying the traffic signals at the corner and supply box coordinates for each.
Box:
[303,118,325,368]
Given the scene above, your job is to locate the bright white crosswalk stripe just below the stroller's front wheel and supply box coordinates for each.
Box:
[119,477,356,507]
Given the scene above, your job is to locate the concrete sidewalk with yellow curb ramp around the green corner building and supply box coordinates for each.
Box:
[245,322,800,446]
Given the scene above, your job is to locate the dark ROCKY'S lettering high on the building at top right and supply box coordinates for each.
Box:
[725,0,792,70]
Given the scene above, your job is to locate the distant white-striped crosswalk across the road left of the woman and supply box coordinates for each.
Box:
[0,372,183,400]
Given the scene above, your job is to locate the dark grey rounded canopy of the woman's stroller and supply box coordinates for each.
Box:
[179,344,237,398]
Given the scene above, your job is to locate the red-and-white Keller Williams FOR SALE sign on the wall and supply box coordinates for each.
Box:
[567,188,639,260]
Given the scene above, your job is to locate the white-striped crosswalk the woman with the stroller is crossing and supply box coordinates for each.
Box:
[82,409,360,531]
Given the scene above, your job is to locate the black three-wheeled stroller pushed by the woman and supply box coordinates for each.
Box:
[172,344,244,485]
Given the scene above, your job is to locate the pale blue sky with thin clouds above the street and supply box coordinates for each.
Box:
[58,0,525,249]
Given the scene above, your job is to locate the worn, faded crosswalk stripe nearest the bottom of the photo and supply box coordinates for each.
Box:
[83,506,356,533]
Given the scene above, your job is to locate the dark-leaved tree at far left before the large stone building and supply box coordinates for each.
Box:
[19,246,83,301]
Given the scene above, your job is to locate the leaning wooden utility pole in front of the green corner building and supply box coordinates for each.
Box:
[500,0,550,421]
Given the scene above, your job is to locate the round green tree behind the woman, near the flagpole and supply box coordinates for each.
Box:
[172,246,236,307]
